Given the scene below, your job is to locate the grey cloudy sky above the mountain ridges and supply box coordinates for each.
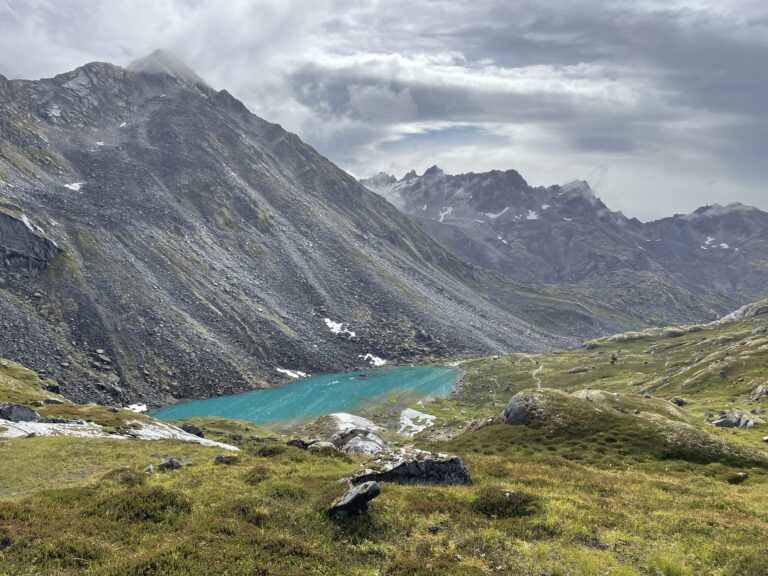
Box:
[0,0,768,219]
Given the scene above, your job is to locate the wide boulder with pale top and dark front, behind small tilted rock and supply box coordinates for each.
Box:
[351,448,472,486]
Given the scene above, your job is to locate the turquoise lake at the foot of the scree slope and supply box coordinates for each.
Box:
[152,366,456,424]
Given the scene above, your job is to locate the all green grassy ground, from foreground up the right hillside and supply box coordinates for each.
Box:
[0,304,768,576]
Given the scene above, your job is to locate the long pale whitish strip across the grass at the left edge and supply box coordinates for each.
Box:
[0,419,239,452]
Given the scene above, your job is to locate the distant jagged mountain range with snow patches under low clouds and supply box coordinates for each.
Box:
[362,166,768,323]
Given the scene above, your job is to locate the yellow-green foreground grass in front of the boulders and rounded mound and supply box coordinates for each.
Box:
[0,434,768,576]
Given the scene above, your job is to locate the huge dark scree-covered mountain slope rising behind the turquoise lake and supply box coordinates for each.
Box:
[0,53,618,404]
